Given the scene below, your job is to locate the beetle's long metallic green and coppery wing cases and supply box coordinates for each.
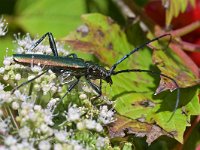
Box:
[13,54,86,70]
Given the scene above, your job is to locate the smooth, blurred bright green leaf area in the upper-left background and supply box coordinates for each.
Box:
[0,0,150,65]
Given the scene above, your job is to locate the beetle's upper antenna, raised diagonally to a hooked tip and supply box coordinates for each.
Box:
[110,34,172,75]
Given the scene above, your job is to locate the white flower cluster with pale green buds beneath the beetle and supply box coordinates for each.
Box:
[0,32,114,150]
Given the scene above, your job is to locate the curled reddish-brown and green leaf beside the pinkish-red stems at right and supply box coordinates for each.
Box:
[153,48,200,93]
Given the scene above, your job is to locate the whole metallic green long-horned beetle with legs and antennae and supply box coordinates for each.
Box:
[12,32,180,115]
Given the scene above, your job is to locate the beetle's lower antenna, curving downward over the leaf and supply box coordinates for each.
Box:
[112,69,180,120]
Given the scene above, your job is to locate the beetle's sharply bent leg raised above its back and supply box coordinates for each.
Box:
[30,32,58,56]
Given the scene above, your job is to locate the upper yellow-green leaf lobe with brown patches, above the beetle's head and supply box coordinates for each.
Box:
[64,14,130,66]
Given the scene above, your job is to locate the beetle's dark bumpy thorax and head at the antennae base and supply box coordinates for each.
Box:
[86,61,112,84]
